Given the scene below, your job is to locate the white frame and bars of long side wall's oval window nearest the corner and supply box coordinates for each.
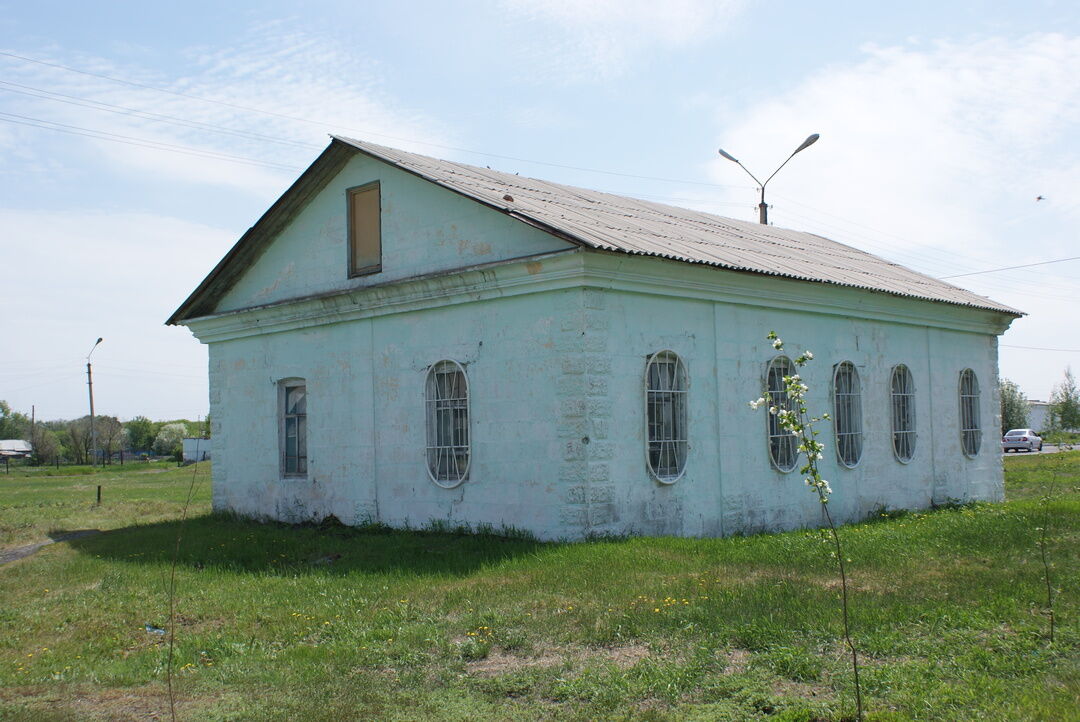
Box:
[644,349,690,485]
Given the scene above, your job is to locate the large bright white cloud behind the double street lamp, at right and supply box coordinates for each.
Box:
[710,33,1080,396]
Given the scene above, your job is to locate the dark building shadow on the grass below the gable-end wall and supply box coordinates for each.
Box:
[70,514,555,576]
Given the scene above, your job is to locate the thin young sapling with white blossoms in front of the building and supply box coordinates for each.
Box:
[750,331,863,720]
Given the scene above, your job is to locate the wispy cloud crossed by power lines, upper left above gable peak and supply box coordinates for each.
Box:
[0,23,445,195]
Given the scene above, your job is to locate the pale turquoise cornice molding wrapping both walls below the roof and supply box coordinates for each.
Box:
[183,248,1012,343]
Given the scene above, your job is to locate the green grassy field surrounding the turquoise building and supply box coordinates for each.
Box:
[0,452,1080,722]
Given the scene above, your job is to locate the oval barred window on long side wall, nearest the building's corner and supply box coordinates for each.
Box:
[645,351,687,483]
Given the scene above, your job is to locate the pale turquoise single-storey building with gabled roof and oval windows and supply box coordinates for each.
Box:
[167,138,1021,539]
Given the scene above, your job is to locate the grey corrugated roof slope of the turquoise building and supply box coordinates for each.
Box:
[335,136,1023,316]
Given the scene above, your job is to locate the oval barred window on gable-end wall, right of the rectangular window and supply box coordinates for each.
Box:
[424,360,471,489]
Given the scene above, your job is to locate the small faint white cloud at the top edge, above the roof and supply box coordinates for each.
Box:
[503,0,744,82]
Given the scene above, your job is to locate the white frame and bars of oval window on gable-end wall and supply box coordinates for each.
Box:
[423,358,472,489]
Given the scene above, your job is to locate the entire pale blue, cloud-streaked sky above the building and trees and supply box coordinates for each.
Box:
[0,0,1080,419]
